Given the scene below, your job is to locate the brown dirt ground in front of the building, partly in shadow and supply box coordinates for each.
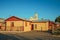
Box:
[0,31,60,40]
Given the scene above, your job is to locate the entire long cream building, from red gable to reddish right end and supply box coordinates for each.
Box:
[5,16,56,32]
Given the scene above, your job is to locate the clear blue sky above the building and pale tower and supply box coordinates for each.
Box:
[0,0,60,20]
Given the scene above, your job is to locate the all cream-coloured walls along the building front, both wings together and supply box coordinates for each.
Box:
[6,21,48,32]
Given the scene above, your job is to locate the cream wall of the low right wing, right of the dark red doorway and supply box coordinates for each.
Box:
[32,22,48,31]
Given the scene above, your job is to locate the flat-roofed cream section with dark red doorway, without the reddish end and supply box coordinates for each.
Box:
[32,21,48,31]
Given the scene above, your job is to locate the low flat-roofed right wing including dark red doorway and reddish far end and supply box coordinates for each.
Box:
[31,21,56,31]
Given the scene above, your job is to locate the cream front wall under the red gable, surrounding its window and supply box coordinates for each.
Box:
[6,21,24,31]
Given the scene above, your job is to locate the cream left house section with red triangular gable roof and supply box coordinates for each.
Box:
[5,16,31,32]
